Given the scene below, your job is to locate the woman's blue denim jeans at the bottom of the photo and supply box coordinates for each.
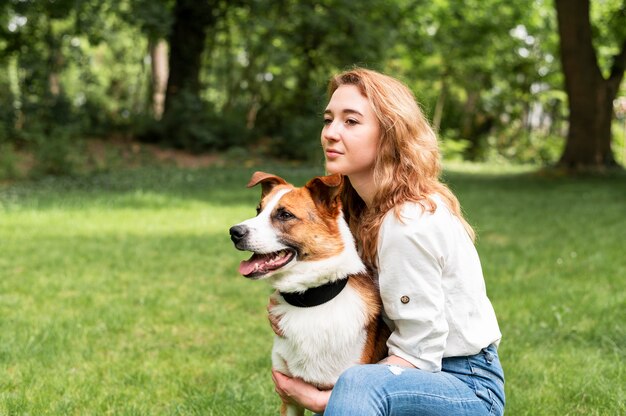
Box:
[324,345,504,416]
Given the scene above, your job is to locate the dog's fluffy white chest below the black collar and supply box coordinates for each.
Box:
[272,286,368,387]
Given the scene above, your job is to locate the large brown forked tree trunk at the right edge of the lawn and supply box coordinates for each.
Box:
[556,0,626,170]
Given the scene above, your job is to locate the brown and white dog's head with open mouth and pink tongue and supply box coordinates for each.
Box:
[230,172,358,279]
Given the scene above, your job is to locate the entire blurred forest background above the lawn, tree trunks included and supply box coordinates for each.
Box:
[0,0,626,178]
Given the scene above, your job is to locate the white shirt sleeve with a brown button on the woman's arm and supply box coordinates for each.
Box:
[378,209,448,372]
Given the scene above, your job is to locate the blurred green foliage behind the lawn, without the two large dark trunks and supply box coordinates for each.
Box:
[0,0,626,166]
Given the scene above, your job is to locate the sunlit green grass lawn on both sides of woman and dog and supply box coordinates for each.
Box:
[0,166,626,415]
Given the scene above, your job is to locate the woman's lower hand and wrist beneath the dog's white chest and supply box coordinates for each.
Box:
[272,369,331,413]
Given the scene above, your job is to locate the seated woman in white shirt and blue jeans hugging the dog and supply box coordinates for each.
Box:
[272,68,504,416]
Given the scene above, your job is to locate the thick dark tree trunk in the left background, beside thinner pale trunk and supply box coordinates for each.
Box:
[164,0,216,116]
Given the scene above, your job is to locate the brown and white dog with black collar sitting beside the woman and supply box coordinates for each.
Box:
[230,172,389,415]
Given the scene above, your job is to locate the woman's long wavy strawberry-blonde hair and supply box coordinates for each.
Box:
[328,68,475,268]
